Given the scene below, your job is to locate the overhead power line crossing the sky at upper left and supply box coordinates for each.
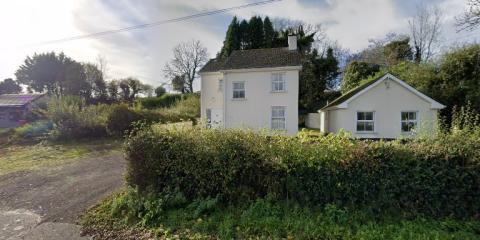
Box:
[34,0,282,45]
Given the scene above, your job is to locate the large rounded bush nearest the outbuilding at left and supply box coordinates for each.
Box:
[45,96,110,139]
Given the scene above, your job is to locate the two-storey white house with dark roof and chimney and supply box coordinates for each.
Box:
[200,36,301,135]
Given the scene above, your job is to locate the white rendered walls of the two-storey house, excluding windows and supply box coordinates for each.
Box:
[201,69,299,135]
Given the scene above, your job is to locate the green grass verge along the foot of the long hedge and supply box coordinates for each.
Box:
[81,190,480,239]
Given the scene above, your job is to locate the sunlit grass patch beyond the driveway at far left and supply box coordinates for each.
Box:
[0,140,121,176]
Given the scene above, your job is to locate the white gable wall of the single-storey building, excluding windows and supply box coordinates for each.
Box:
[322,81,437,138]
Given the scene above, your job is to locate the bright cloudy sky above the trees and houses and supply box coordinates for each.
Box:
[0,0,480,89]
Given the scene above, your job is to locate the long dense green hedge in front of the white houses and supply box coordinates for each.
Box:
[126,126,480,216]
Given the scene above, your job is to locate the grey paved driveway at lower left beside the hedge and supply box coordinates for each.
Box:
[0,153,125,240]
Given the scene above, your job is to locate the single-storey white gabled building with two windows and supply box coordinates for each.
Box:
[319,74,445,139]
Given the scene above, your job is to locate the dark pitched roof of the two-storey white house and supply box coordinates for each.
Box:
[200,48,302,72]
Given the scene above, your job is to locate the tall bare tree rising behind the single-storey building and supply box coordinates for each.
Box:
[408,5,442,63]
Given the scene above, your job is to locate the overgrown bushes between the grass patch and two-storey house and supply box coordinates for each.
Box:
[34,94,200,140]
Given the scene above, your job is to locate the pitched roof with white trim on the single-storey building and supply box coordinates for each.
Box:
[321,73,445,110]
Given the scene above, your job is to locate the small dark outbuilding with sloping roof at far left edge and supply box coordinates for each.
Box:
[0,94,44,128]
